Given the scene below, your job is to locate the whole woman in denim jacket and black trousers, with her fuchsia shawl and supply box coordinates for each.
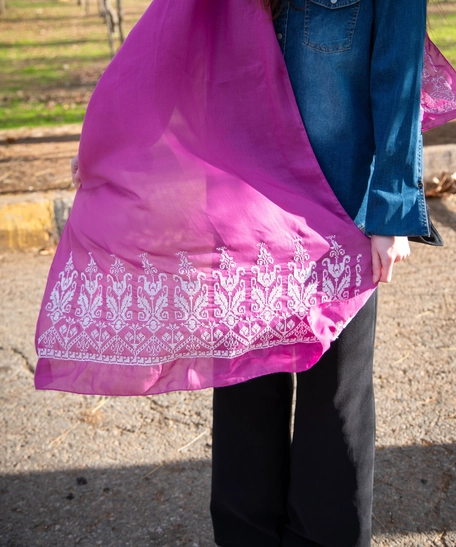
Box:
[35,0,454,547]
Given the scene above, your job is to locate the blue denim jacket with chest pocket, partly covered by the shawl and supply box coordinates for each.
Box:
[275,0,429,236]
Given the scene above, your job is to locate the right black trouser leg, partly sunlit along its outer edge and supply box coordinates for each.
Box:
[282,293,377,547]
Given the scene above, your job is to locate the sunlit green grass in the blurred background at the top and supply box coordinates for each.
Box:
[0,0,456,128]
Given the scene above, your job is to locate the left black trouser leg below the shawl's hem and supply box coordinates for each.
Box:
[211,373,293,547]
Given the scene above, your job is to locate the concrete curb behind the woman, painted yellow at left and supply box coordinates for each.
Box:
[0,144,456,251]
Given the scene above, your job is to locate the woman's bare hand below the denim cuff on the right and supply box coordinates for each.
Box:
[371,236,410,283]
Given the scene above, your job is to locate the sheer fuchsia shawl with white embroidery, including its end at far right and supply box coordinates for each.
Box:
[35,0,456,395]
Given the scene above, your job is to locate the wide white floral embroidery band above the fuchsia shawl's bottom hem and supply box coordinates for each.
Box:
[38,236,362,366]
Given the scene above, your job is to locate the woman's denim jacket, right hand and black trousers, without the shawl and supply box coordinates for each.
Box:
[211,0,428,547]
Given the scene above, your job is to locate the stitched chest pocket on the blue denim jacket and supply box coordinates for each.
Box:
[304,0,361,53]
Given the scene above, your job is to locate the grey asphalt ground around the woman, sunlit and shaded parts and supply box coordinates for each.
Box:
[0,198,456,547]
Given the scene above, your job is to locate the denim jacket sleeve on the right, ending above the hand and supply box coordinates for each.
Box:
[366,0,429,236]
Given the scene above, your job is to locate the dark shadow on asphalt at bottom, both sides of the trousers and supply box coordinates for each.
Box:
[0,444,456,547]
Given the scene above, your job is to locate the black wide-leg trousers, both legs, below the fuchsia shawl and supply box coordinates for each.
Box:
[211,293,377,547]
